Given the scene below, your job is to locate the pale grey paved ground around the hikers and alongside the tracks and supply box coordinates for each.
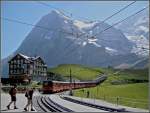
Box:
[1,92,149,112]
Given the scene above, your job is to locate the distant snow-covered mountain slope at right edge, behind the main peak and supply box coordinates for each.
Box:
[117,10,149,57]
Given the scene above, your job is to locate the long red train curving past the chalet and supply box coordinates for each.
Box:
[42,75,107,94]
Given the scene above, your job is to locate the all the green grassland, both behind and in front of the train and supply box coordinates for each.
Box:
[49,65,148,109]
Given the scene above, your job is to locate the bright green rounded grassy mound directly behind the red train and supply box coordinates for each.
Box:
[48,64,102,80]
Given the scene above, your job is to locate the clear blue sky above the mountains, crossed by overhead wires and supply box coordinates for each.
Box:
[1,1,148,58]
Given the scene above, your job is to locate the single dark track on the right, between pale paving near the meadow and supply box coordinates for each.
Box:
[60,96,129,112]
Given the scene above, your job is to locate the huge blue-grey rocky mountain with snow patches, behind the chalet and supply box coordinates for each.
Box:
[2,11,148,75]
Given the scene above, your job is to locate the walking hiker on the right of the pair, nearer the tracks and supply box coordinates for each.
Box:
[24,88,35,111]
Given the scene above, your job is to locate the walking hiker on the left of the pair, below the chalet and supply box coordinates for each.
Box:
[7,84,17,109]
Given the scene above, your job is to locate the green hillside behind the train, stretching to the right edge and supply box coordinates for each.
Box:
[48,64,148,84]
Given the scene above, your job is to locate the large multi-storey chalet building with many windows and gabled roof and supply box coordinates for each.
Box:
[8,53,47,82]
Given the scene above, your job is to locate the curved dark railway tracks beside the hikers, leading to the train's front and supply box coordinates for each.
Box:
[33,96,73,112]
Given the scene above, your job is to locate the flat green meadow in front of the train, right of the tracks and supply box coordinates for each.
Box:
[74,83,148,109]
